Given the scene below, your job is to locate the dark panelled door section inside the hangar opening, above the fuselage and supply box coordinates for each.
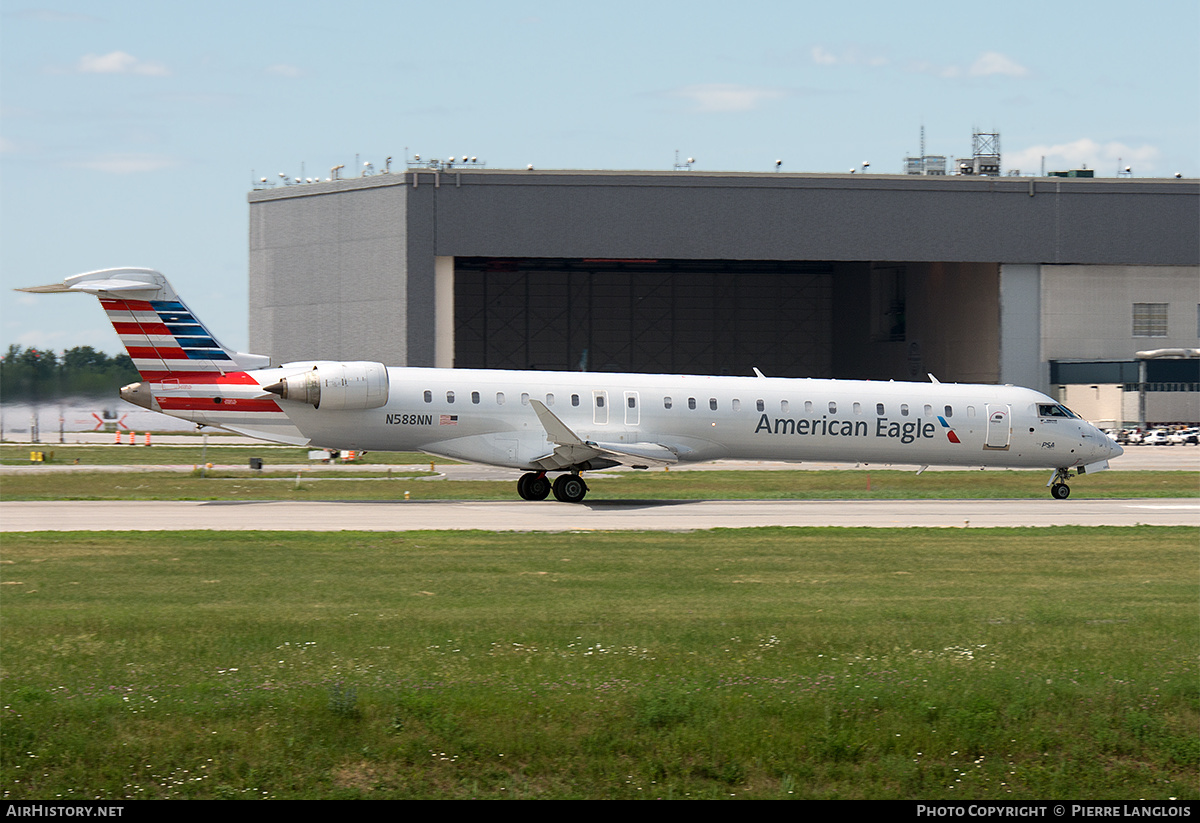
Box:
[454,258,834,377]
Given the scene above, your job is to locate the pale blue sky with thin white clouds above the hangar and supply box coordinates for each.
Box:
[0,0,1200,353]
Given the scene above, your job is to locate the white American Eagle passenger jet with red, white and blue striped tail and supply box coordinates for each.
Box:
[19,268,1122,503]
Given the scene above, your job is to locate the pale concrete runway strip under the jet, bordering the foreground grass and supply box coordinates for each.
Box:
[0,498,1200,531]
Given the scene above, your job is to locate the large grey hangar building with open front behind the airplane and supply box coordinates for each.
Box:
[250,168,1200,421]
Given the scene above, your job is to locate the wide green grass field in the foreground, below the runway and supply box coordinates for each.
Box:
[0,527,1200,799]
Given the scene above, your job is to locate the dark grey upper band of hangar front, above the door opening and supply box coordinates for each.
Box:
[250,169,1200,265]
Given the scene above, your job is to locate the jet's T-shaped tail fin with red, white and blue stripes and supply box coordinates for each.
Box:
[18,269,271,383]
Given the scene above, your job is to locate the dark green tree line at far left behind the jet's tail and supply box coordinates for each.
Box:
[0,346,139,402]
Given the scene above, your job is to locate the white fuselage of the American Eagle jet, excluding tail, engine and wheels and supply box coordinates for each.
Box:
[243,365,1121,469]
